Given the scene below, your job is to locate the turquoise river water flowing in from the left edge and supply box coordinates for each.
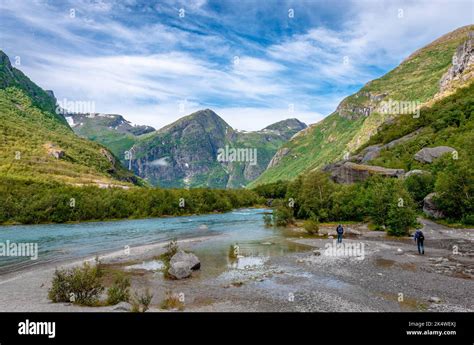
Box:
[0,209,273,273]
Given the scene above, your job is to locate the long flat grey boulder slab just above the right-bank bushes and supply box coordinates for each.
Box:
[323,162,405,183]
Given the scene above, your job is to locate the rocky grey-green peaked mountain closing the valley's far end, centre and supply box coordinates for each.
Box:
[131,109,306,188]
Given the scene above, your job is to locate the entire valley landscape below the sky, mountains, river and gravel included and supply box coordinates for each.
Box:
[0,25,474,318]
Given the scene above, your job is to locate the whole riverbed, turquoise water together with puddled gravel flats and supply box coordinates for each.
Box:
[0,209,474,312]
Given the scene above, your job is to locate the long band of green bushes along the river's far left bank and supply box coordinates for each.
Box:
[0,177,264,224]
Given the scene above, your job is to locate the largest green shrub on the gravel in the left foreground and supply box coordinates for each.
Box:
[48,262,104,306]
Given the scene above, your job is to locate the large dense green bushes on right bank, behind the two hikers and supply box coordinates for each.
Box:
[258,171,416,236]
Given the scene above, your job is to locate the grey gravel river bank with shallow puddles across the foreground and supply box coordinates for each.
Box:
[0,212,474,312]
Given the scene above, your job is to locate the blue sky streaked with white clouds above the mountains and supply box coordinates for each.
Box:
[0,0,474,130]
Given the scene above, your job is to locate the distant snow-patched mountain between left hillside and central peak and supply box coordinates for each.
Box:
[65,113,155,163]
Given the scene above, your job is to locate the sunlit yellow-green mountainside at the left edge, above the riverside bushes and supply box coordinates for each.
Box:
[0,51,138,187]
